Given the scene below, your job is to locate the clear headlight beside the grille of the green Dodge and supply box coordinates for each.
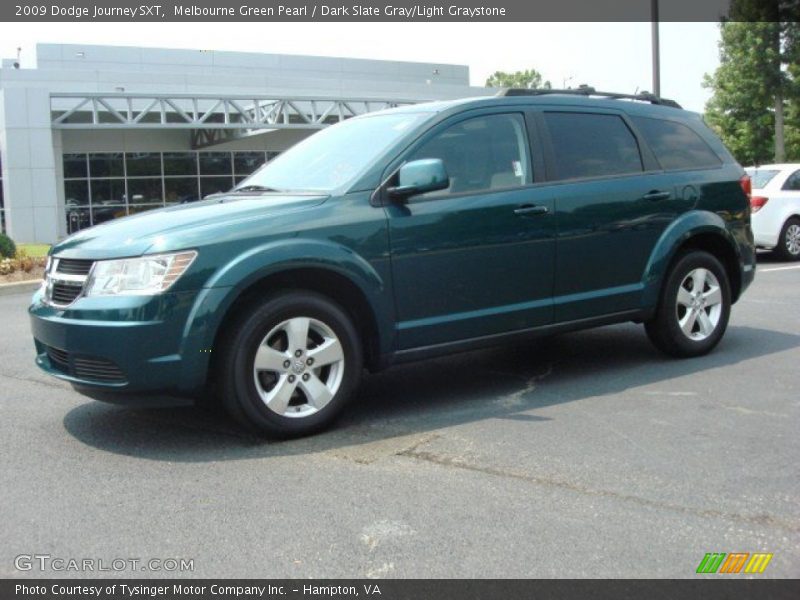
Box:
[84,252,197,296]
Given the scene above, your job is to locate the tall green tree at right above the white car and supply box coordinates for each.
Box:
[703,0,800,164]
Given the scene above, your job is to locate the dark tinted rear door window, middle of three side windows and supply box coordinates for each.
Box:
[544,112,642,179]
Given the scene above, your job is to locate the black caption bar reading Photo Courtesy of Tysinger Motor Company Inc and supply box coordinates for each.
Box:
[0,576,800,600]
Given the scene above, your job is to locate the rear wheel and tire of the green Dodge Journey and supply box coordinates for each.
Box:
[645,251,731,358]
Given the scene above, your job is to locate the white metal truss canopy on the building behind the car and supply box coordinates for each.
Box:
[50,92,416,149]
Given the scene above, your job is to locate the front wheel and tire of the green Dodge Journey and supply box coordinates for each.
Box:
[218,291,363,437]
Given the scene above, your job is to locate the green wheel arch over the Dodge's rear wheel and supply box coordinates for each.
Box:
[642,210,741,308]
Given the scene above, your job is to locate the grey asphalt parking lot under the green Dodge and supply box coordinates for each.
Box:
[0,258,800,578]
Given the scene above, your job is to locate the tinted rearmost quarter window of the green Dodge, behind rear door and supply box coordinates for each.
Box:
[632,117,722,170]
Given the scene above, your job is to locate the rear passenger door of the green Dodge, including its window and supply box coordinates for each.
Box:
[539,107,686,322]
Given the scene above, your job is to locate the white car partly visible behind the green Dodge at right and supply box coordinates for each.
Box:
[745,163,800,260]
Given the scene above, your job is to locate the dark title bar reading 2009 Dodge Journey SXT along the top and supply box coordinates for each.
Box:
[0,0,776,22]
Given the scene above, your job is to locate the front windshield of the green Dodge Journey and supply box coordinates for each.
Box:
[236,113,429,192]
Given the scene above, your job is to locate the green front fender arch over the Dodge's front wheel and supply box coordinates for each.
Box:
[181,238,394,395]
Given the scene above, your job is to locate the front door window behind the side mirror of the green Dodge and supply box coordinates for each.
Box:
[408,114,532,199]
